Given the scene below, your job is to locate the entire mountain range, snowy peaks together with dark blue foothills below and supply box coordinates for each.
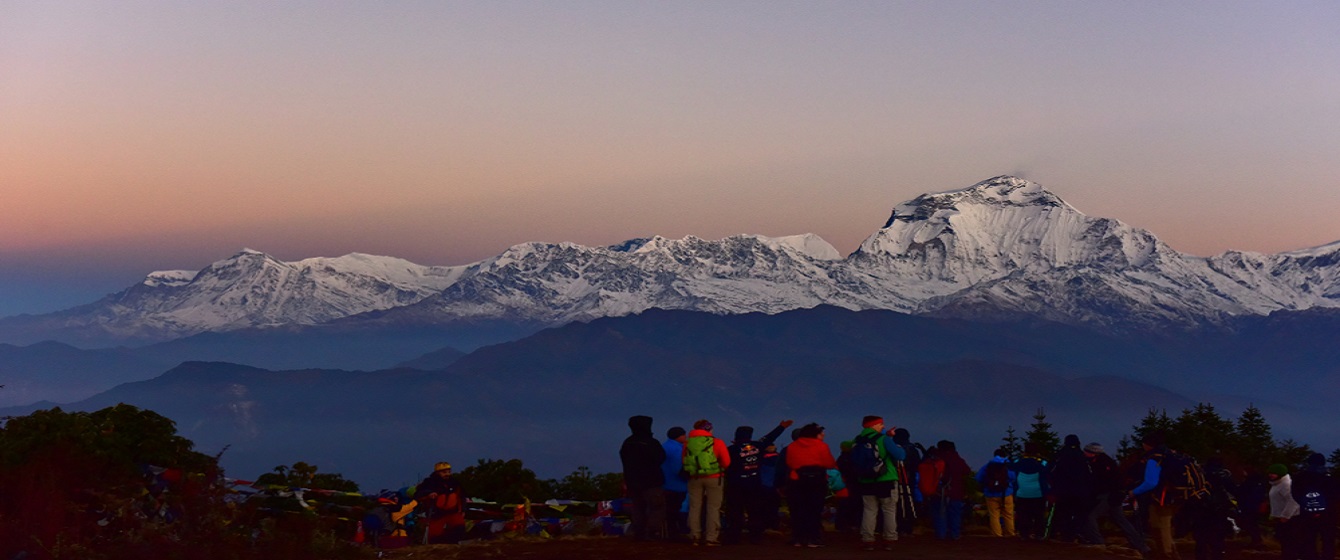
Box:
[0,177,1340,485]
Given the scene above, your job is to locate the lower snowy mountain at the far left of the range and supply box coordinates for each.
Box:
[5,249,465,342]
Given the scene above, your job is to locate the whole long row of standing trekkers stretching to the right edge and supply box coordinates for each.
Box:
[620,415,1340,560]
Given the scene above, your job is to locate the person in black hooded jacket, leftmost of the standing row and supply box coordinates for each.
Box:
[619,415,666,540]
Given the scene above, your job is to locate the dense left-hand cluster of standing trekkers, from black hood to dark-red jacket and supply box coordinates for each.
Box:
[619,415,973,549]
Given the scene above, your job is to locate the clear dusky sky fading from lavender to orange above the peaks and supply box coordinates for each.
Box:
[0,0,1340,316]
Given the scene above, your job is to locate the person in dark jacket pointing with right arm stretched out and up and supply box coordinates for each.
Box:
[724,419,792,544]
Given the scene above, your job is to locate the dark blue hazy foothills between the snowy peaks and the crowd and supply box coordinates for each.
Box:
[0,305,1340,489]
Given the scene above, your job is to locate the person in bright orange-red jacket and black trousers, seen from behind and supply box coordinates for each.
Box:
[787,422,838,548]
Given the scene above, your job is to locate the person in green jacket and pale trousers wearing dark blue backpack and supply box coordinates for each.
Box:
[848,415,907,551]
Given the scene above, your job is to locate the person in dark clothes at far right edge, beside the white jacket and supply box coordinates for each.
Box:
[1289,453,1340,560]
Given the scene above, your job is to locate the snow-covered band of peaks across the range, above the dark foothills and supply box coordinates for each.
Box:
[4,177,1340,339]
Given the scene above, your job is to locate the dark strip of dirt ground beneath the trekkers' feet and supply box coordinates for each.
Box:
[382,532,1280,560]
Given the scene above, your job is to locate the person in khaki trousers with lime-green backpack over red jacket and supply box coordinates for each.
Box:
[682,419,730,547]
